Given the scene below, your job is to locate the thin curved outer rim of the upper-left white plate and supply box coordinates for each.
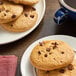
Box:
[0,0,46,45]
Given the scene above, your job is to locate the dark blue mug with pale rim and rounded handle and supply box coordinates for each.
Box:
[54,0,76,24]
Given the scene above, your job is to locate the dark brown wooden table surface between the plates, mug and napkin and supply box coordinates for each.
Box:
[0,0,76,76]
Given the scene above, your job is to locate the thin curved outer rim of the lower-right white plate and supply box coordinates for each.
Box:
[20,35,76,76]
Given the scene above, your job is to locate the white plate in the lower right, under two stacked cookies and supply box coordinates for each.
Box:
[20,35,76,76]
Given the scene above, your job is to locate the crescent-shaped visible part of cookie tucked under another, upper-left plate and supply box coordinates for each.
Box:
[1,6,38,32]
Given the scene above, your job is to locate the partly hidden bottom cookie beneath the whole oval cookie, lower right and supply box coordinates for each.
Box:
[36,55,76,76]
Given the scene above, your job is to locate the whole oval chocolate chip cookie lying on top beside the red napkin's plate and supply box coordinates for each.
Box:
[30,40,74,70]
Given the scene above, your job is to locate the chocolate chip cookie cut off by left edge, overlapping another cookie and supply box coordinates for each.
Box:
[0,0,23,23]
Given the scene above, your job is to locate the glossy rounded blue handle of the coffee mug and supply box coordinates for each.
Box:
[54,8,68,24]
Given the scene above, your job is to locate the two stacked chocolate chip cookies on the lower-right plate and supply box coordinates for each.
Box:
[30,40,76,76]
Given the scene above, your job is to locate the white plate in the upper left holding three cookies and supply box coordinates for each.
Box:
[0,0,45,45]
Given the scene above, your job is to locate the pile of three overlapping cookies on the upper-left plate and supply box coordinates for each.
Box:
[0,0,38,32]
